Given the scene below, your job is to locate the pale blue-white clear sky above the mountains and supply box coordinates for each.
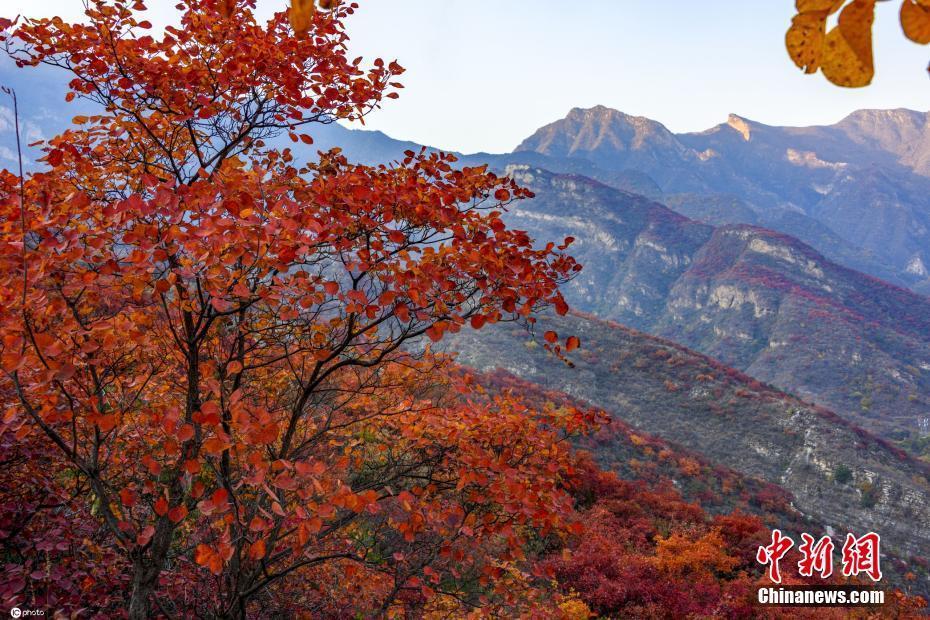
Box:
[0,0,930,152]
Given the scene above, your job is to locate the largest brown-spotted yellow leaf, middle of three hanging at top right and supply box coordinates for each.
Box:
[821,0,875,88]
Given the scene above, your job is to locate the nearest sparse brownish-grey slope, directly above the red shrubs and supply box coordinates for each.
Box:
[448,316,930,568]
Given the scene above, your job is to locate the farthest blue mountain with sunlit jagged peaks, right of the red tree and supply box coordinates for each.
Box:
[517,107,930,290]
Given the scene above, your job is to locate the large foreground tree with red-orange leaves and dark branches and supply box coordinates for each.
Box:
[0,0,583,618]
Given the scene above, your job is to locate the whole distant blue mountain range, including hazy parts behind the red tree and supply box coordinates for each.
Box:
[7,61,930,293]
